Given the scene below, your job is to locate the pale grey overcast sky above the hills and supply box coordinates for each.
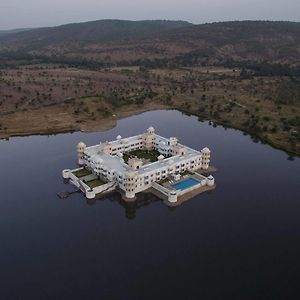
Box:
[0,0,300,30]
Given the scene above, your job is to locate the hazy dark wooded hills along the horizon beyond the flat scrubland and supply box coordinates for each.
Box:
[0,20,300,66]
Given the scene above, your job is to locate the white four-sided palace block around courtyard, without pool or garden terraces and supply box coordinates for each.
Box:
[77,127,210,199]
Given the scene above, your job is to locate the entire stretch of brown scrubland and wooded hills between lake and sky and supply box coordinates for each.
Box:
[0,20,300,155]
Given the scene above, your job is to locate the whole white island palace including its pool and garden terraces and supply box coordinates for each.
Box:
[63,127,215,204]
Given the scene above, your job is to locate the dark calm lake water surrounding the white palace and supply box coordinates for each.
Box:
[0,111,300,300]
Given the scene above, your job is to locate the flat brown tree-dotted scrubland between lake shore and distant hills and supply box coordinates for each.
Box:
[0,65,300,154]
